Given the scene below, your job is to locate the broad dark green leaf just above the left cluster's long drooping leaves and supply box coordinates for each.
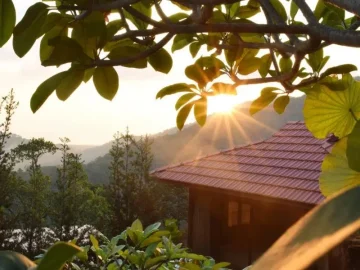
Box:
[42,36,91,67]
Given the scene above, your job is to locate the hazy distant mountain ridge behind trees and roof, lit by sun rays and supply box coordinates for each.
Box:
[14,94,304,184]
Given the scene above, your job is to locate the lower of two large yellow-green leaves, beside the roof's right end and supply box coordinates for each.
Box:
[319,137,360,196]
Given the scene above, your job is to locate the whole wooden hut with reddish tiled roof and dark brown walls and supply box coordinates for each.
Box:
[153,122,346,270]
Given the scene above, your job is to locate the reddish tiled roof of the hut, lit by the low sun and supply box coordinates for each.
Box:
[152,121,331,204]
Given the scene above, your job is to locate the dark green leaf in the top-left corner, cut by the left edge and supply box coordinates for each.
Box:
[0,0,16,48]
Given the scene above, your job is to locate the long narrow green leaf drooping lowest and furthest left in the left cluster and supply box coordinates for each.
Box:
[30,71,67,113]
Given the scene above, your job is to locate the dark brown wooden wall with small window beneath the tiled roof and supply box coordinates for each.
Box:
[188,187,346,270]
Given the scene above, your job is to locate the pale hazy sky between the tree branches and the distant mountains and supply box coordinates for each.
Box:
[0,0,360,144]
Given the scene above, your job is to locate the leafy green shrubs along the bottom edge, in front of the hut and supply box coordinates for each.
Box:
[0,220,229,270]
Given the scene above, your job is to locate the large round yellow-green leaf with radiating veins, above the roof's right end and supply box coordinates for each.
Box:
[304,75,360,139]
